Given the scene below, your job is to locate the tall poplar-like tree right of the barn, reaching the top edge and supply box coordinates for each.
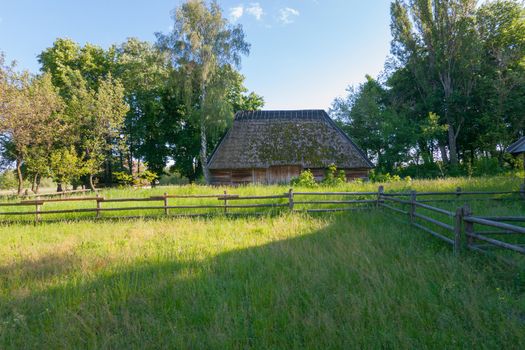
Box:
[391,0,479,166]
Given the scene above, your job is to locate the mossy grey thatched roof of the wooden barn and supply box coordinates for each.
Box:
[208,110,373,169]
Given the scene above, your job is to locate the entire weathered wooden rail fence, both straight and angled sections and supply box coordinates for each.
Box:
[0,186,525,262]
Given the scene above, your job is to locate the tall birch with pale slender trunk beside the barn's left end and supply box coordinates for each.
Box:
[157,0,250,182]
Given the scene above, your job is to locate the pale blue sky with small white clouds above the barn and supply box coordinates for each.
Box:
[0,0,390,109]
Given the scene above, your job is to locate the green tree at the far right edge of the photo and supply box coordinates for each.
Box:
[469,1,525,159]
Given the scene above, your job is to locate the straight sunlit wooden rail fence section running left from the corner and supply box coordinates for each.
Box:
[0,189,377,223]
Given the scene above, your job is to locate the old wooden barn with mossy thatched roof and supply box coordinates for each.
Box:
[208,110,373,185]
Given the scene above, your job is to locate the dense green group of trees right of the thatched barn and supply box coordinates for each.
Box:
[331,0,525,177]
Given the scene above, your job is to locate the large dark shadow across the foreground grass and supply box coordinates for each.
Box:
[0,214,525,349]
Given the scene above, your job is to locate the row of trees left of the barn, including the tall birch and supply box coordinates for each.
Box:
[0,0,264,193]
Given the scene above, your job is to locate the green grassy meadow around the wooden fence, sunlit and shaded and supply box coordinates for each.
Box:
[0,178,525,349]
